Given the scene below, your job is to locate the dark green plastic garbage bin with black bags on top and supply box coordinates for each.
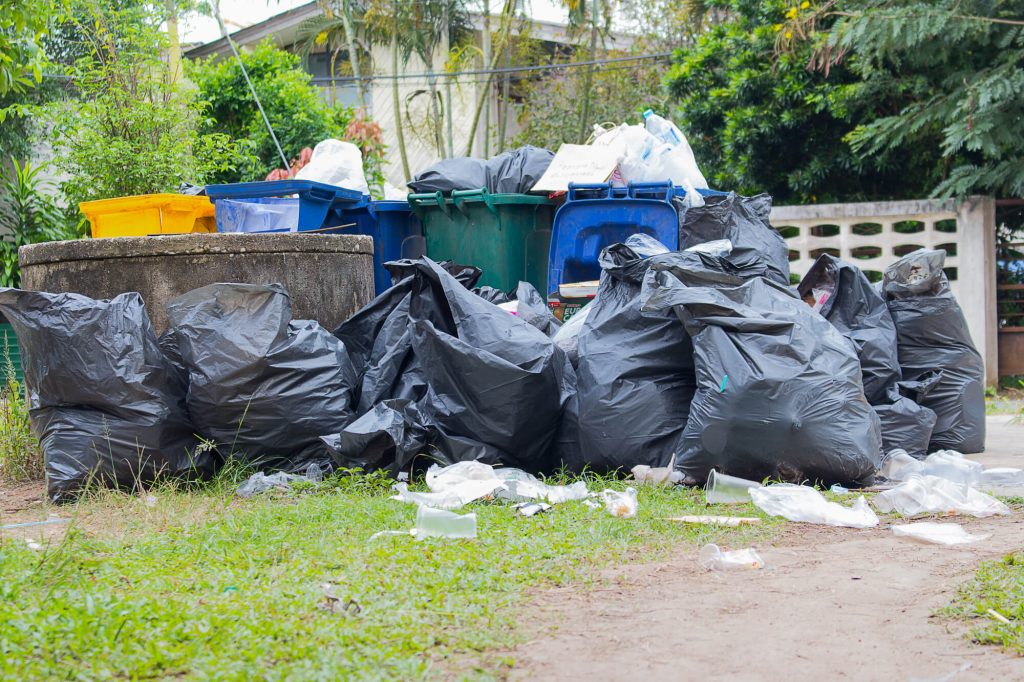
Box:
[409,189,555,295]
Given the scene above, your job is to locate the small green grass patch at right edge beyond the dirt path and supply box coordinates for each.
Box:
[943,552,1024,655]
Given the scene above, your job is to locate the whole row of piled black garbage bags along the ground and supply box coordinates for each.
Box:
[0,195,984,500]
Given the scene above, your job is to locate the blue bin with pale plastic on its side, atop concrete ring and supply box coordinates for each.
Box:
[206,180,362,232]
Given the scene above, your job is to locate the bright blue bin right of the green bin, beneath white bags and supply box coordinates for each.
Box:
[548,182,679,295]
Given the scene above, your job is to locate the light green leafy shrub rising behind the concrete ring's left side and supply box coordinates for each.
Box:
[49,4,240,204]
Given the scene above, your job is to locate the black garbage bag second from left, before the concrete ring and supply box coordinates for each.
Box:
[167,284,355,472]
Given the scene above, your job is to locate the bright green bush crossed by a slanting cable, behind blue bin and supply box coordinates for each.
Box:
[186,40,353,182]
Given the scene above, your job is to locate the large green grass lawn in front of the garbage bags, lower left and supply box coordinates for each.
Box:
[0,474,781,680]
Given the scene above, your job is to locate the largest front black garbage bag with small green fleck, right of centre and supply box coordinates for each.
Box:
[643,263,882,483]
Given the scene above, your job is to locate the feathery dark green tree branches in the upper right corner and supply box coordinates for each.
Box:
[815,0,1024,197]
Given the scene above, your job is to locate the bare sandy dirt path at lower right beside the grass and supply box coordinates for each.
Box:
[512,422,1024,682]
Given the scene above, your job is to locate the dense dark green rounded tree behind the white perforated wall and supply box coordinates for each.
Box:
[668,0,941,203]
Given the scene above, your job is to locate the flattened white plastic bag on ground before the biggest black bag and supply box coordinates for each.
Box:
[750,483,879,528]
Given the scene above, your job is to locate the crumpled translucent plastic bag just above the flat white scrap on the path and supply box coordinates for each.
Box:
[873,474,1010,518]
